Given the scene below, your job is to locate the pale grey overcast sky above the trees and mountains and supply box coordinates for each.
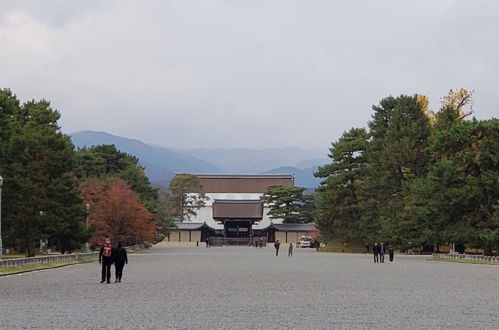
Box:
[0,0,499,153]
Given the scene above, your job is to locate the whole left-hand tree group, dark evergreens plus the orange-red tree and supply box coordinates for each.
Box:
[0,89,176,256]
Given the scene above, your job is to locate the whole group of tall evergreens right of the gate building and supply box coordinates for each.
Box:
[315,89,499,254]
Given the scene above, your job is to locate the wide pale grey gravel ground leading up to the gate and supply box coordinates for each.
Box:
[0,247,499,329]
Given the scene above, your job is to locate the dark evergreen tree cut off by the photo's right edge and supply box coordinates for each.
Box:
[411,119,499,254]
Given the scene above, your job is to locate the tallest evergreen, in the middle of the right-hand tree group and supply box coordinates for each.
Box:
[359,95,431,242]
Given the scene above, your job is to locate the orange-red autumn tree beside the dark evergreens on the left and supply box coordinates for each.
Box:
[80,179,156,244]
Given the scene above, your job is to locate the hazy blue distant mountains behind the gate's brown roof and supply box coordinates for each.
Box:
[70,131,328,188]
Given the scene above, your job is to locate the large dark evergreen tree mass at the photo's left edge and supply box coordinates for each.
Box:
[0,91,88,256]
